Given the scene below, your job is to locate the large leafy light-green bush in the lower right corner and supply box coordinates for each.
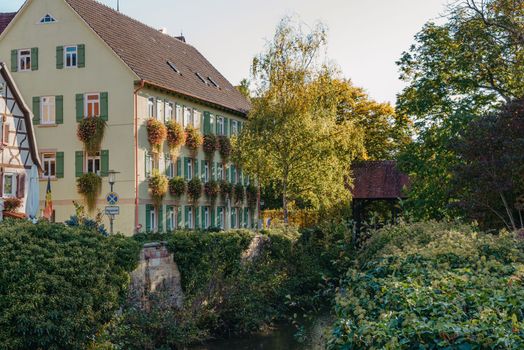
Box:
[328,222,524,349]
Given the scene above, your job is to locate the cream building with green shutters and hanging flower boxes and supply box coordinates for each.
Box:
[0,0,256,234]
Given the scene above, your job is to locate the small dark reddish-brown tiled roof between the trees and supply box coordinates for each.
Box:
[352,161,409,199]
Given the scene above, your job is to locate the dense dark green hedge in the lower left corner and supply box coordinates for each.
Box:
[0,220,139,349]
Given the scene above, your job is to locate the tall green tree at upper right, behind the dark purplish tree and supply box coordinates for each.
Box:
[397,0,524,218]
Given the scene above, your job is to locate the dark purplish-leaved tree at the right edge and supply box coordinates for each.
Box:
[451,100,524,230]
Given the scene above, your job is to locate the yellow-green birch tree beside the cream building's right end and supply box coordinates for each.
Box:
[235,18,363,222]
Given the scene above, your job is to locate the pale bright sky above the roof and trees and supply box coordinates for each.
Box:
[0,0,449,103]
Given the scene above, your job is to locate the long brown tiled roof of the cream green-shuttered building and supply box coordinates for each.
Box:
[66,0,250,114]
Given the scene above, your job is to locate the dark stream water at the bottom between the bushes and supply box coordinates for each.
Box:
[191,316,330,350]
